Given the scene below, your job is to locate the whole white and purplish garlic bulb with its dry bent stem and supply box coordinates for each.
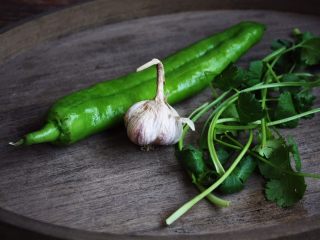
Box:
[124,59,194,146]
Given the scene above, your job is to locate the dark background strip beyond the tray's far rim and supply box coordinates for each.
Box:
[0,0,319,29]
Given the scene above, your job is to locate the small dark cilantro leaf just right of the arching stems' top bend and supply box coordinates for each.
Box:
[237,92,264,123]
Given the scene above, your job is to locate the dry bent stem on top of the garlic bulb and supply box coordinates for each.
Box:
[137,58,165,102]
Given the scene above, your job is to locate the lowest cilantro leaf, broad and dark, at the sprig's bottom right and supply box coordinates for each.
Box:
[265,174,306,207]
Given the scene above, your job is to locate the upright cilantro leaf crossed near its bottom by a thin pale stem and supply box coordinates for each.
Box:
[274,92,299,128]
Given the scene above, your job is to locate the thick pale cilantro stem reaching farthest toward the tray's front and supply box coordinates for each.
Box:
[166,131,253,225]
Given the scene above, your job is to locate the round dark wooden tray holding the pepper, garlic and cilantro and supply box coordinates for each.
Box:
[0,0,320,239]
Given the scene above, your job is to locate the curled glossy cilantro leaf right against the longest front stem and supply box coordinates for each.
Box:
[219,155,257,193]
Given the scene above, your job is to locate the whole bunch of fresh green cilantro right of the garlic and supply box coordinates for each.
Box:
[166,29,320,225]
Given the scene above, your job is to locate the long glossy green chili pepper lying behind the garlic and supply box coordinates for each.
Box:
[14,22,265,145]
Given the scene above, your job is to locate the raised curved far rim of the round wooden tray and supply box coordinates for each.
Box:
[0,0,320,63]
